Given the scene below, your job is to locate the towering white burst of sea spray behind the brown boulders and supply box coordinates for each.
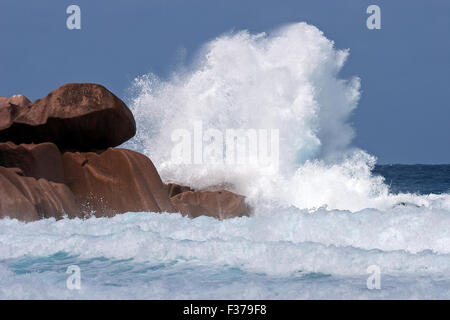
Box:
[123,23,446,215]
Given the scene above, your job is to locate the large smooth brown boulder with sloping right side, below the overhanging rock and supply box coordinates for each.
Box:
[62,148,175,217]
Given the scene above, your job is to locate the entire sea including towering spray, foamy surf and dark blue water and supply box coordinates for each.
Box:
[0,23,450,299]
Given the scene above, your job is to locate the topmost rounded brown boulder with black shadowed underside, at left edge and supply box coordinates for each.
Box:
[0,83,136,151]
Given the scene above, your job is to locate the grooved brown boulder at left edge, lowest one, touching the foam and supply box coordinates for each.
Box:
[0,167,82,221]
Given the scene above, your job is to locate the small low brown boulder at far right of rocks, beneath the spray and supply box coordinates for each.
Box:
[170,190,250,219]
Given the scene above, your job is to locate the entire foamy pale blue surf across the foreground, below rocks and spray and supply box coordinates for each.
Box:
[0,207,450,299]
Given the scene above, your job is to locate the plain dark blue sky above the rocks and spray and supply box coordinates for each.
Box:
[0,0,450,163]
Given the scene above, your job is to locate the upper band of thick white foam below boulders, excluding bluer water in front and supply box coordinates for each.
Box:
[0,208,450,275]
